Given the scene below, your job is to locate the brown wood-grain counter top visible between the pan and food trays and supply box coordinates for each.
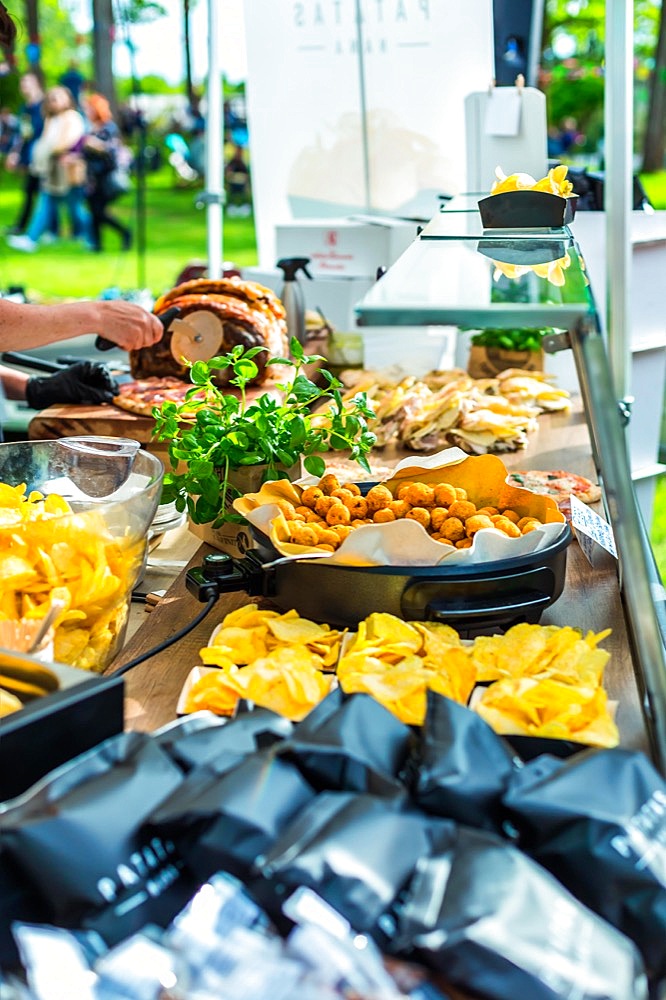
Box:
[109,394,649,752]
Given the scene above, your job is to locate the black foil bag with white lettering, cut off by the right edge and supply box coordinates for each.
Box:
[504,749,666,978]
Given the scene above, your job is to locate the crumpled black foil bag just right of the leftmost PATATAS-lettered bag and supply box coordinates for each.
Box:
[148,749,315,881]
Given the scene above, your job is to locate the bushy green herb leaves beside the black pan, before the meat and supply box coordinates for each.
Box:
[153,338,375,527]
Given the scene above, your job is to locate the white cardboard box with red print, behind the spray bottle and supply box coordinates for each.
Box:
[275,215,417,281]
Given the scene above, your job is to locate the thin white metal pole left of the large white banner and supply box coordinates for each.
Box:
[204,0,224,278]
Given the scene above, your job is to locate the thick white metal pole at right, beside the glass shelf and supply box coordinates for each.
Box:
[604,0,634,400]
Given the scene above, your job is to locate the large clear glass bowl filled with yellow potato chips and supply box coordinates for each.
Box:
[0,436,164,673]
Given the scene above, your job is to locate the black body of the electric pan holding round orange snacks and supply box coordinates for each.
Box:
[188,524,572,634]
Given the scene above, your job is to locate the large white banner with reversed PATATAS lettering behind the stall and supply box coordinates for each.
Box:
[245,0,493,267]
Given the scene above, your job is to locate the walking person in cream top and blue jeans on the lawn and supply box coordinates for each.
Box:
[7,86,90,253]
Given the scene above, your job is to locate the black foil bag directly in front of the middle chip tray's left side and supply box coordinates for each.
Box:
[278,688,412,797]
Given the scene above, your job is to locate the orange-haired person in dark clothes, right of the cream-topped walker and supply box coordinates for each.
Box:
[83,94,132,252]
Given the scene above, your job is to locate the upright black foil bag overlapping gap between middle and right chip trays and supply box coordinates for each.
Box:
[407,691,519,833]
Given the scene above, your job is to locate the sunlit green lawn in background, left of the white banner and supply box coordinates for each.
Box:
[0,168,257,301]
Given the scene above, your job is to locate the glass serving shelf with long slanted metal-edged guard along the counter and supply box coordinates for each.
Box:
[356,213,666,773]
